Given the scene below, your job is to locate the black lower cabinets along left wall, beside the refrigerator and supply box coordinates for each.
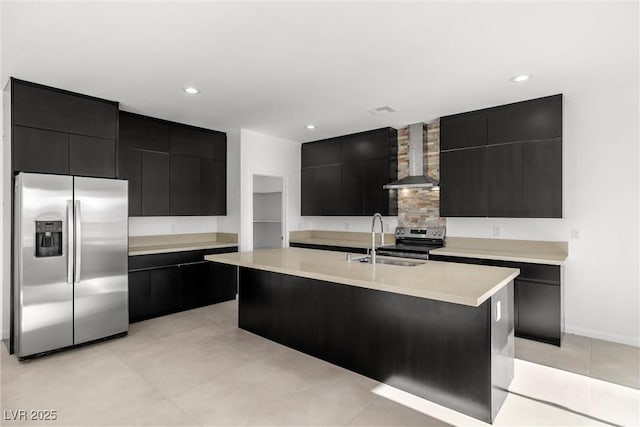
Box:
[129,247,238,323]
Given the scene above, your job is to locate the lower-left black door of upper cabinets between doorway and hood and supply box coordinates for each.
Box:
[300,165,342,215]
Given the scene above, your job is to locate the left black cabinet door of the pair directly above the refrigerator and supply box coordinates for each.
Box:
[12,126,69,175]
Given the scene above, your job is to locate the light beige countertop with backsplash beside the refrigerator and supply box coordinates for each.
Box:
[129,233,238,256]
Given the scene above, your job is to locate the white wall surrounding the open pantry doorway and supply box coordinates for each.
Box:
[240,129,300,251]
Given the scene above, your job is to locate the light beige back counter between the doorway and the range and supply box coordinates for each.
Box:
[289,230,396,249]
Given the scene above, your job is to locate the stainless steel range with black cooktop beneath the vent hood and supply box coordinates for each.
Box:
[377,227,446,259]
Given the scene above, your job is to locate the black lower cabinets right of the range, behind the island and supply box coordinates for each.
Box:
[429,254,564,346]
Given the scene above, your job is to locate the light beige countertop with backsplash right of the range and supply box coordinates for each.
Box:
[429,237,569,265]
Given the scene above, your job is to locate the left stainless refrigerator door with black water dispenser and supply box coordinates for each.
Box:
[14,173,73,357]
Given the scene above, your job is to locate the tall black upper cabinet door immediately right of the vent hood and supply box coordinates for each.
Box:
[440,147,487,217]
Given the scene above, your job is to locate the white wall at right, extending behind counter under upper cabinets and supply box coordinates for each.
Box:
[447,83,640,346]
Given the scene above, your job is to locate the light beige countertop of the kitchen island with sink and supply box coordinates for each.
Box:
[204,248,520,307]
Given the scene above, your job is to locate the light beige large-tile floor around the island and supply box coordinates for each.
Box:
[0,302,640,426]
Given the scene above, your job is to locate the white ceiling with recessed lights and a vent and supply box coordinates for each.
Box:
[2,1,638,142]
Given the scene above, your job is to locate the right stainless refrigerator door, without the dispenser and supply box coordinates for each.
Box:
[73,177,129,344]
